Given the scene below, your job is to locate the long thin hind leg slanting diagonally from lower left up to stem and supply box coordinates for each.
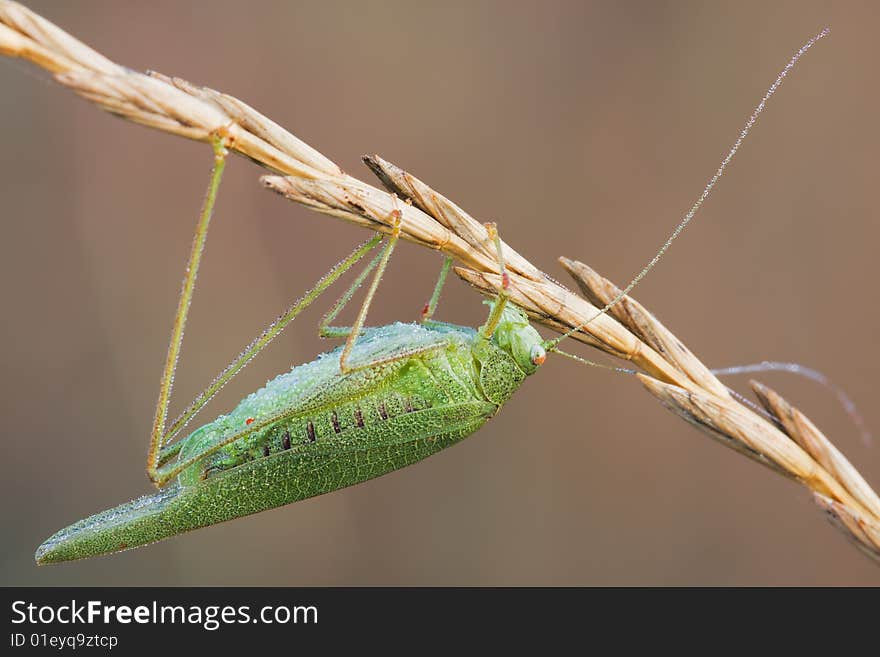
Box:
[148,235,382,482]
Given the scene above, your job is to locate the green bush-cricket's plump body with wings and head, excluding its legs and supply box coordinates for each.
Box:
[36,307,541,563]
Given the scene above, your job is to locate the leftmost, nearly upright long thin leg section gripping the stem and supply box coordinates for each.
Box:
[147,135,228,479]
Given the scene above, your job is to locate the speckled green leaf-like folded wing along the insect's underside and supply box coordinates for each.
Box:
[36,402,495,563]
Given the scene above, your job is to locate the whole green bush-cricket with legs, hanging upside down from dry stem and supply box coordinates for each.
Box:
[35,138,558,564]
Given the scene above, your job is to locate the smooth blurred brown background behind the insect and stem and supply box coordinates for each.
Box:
[0,1,880,585]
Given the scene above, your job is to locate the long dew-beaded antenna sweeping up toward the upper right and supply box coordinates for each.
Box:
[546,27,831,351]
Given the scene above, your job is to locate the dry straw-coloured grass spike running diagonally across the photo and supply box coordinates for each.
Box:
[0,0,880,561]
